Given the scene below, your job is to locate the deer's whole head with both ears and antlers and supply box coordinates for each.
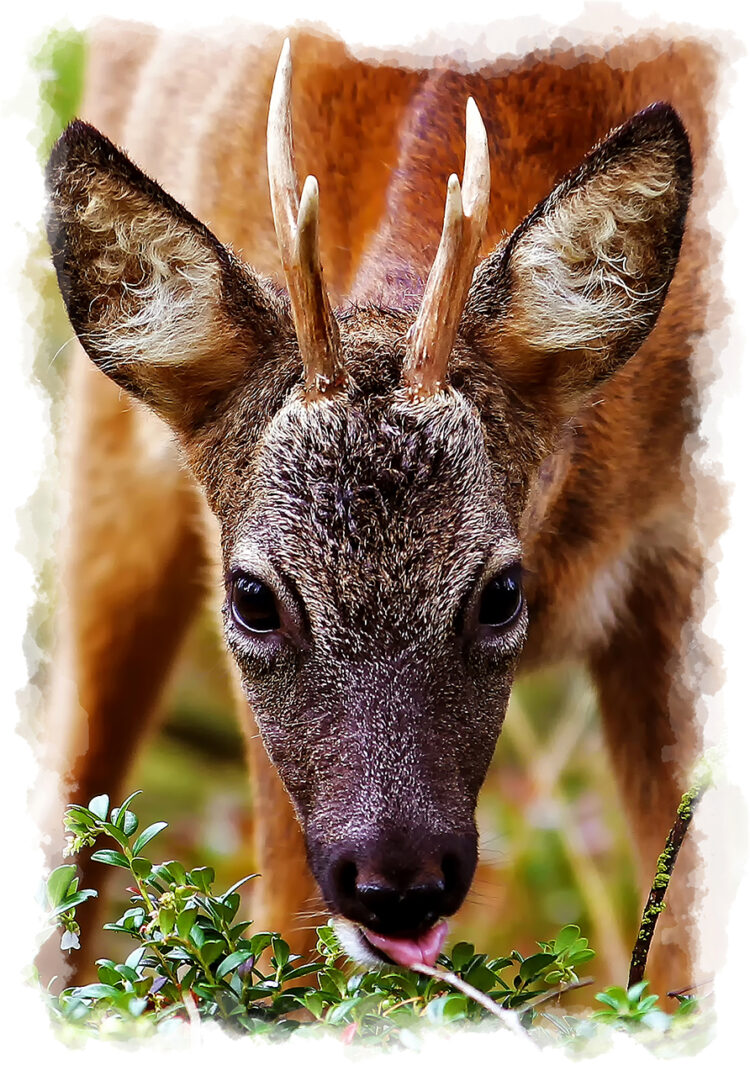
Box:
[48,41,691,963]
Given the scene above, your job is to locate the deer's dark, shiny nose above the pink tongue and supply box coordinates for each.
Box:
[322,837,477,937]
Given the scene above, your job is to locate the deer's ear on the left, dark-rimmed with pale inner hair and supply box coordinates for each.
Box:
[47,121,294,429]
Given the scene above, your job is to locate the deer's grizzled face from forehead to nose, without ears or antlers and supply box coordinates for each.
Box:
[219,380,525,959]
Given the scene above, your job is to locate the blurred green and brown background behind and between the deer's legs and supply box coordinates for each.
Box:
[31,23,641,1003]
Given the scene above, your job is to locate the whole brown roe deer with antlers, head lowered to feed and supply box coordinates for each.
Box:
[43,25,712,988]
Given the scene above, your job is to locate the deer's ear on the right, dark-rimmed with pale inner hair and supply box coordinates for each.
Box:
[462,104,692,416]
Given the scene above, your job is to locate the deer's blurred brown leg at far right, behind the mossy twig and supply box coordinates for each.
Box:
[590,550,699,997]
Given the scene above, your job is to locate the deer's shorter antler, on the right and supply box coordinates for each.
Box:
[404,97,490,399]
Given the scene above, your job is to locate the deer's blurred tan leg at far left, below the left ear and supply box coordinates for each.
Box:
[37,353,206,977]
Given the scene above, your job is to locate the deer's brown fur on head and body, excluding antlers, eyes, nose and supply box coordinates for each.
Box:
[39,25,713,987]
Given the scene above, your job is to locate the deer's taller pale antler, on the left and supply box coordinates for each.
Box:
[267,39,344,398]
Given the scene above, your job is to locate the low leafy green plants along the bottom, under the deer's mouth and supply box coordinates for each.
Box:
[47,793,705,1046]
